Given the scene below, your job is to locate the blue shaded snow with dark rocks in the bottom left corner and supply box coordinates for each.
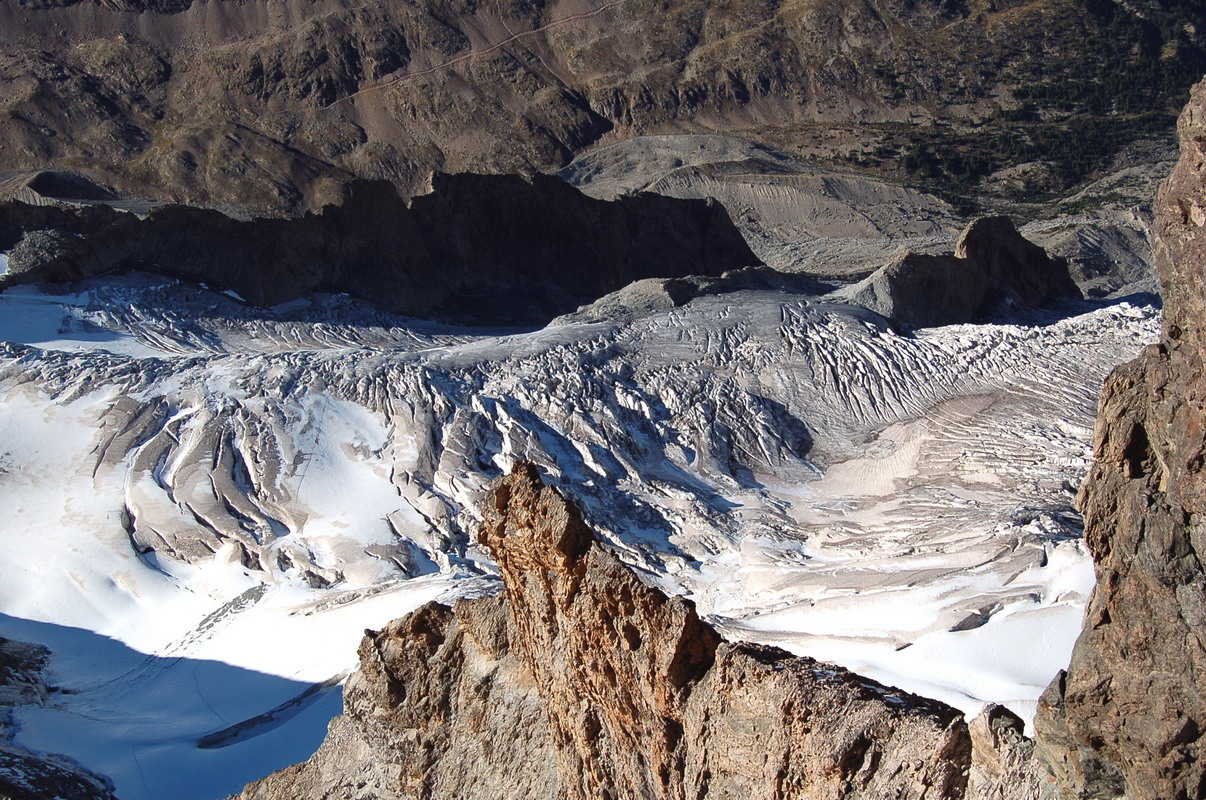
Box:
[0,614,340,800]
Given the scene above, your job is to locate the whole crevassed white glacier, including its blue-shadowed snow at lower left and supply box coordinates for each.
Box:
[0,278,1158,800]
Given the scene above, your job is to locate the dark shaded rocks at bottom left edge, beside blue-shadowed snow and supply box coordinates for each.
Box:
[0,637,116,800]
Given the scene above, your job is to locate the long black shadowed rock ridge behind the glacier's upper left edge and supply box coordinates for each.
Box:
[0,174,759,323]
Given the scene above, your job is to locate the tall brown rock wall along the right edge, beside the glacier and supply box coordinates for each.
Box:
[1036,82,1206,800]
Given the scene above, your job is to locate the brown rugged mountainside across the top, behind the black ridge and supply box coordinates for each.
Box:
[0,0,1206,211]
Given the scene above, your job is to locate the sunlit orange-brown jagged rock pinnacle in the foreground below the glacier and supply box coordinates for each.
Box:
[241,465,988,800]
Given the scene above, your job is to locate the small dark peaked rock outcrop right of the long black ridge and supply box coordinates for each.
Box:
[841,217,1081,328]
